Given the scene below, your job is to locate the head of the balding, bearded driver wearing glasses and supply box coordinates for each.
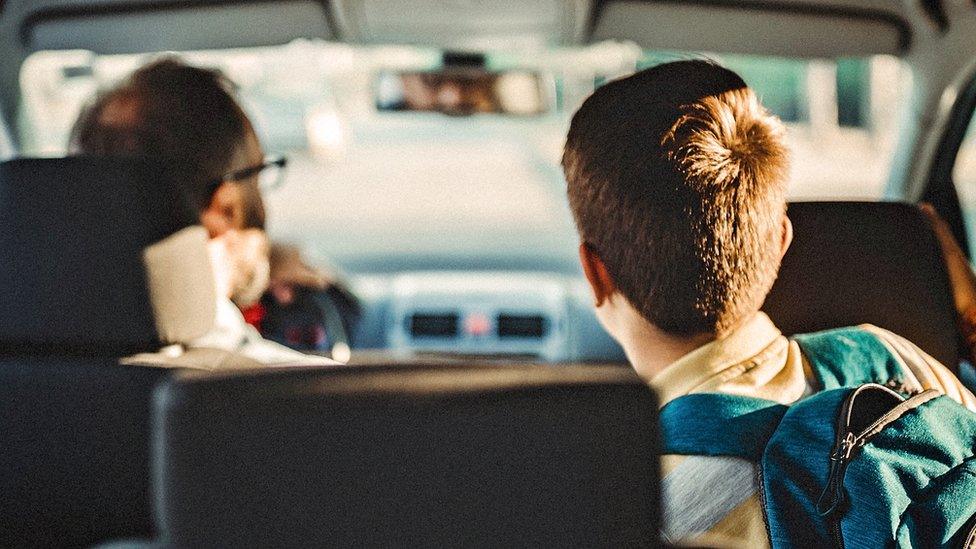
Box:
[71,57,269,306]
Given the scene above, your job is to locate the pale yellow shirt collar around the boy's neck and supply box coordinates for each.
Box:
[650,312,782,406]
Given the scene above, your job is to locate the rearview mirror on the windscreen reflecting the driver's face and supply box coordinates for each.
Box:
[376,68,551,116]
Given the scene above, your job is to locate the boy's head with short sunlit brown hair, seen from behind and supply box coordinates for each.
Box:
[563,57,791,337]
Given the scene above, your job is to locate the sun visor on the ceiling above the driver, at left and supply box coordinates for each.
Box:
[21,0,331,54]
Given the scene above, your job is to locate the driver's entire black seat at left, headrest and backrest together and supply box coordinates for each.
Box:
[0,158,214,547]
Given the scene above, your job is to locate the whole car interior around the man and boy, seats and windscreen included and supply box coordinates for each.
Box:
[0,0,976,547]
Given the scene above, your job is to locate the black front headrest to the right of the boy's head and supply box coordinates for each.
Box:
[763,202,959,371]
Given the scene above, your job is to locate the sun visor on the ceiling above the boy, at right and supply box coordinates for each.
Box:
[591,0,911,59]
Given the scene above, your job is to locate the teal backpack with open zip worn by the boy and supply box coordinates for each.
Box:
[660,328,976,549]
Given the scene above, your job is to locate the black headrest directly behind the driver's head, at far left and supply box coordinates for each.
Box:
[0,157,197,353]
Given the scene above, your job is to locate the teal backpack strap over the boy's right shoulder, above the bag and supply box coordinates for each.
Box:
[793,327,905,390]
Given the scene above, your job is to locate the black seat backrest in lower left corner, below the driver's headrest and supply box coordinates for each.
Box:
[0,357,171,547]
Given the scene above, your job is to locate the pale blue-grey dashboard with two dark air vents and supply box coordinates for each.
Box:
[349,271,625,362]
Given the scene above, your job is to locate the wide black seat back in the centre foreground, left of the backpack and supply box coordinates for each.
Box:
[154,366,660,547]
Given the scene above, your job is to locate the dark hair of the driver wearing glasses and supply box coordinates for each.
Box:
[71,56,265,228]
